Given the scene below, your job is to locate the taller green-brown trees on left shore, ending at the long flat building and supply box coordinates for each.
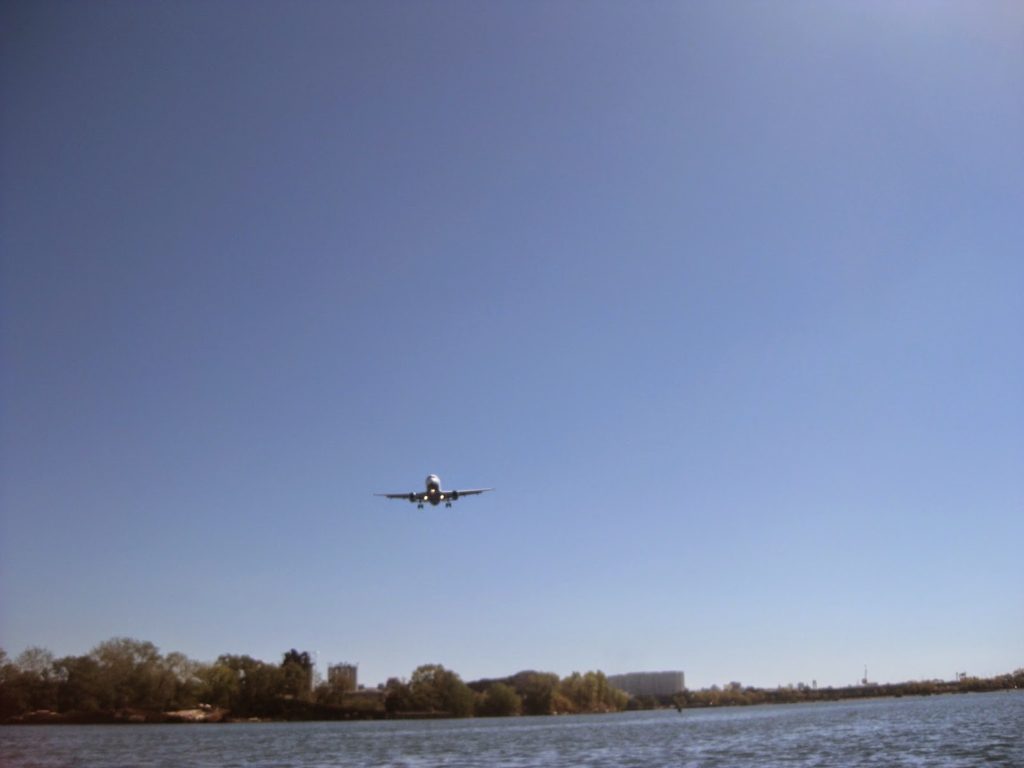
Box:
[0,638,629,722]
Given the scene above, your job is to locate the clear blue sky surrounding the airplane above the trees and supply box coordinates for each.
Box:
[0,1,1024,687]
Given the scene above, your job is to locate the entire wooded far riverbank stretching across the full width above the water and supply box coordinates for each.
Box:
[0,638,1024,724]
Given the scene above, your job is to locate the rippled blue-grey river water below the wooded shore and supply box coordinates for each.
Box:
[0,691,1024,768]
